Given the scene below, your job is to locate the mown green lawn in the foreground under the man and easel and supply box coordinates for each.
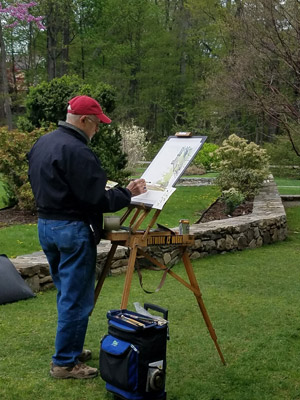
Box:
[0,207,300,400]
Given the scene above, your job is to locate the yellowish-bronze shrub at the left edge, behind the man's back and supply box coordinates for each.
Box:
[0,128,52,210]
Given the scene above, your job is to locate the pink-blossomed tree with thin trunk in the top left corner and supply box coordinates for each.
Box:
[0,1,45,130]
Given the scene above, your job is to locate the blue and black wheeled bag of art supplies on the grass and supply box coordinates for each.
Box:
[99,306,168,400]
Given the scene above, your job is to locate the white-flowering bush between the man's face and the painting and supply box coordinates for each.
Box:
[120,121,150,167]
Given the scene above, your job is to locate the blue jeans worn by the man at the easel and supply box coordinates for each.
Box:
[38,218,96,367]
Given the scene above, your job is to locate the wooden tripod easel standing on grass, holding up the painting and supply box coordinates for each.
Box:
[95,206,225,365]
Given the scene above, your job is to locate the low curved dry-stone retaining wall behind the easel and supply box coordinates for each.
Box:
[11,180,287,292]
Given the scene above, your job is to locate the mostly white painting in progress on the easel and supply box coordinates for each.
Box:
[131,136,207,210]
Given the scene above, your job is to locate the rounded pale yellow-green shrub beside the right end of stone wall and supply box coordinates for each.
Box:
[216,135,269,198]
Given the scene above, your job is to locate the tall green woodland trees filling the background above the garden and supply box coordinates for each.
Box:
[0,0,300,155]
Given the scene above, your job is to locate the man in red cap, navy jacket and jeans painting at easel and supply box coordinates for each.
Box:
[28,96,146,379]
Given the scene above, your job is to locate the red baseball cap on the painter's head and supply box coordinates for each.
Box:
[68,96,111,124]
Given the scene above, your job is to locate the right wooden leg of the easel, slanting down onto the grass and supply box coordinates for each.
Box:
[182,250,226,365]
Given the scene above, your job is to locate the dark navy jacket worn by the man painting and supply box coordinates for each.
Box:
[27,122,131,241]
